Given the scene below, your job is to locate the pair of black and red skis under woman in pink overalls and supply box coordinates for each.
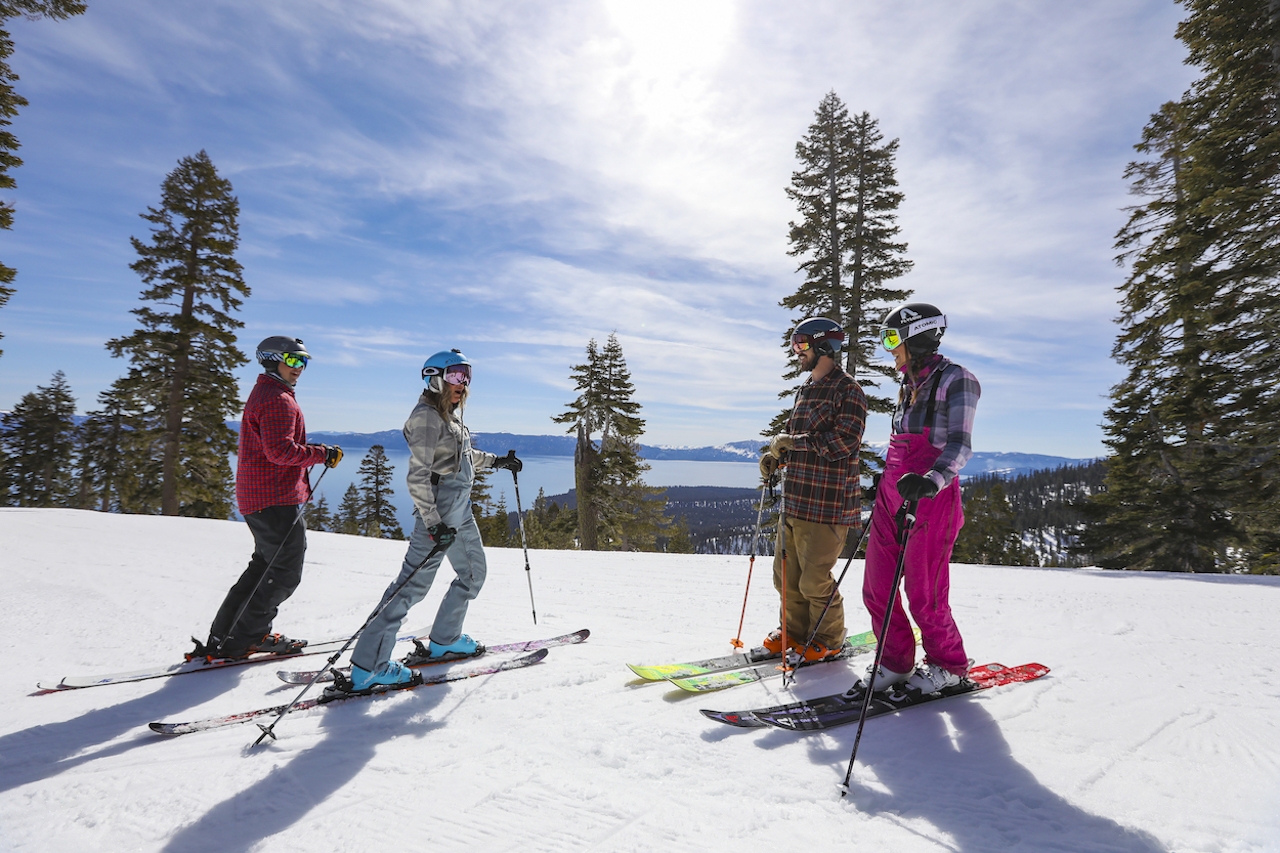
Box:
[701,663,1050,731]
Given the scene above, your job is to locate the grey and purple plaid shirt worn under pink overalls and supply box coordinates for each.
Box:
[893,353,982,489]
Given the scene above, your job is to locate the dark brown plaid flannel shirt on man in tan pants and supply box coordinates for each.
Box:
[782,368,867,528]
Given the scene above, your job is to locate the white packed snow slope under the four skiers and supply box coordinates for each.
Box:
[0,510,1280,853]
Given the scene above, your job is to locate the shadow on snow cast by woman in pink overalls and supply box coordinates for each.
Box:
[810,701,1167,853]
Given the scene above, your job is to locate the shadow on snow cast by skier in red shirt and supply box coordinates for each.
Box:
[0,672,241,792]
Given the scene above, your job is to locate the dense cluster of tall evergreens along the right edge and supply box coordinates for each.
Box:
[1082,0,1280,571]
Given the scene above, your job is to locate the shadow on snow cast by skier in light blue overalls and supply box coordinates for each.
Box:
[164,688,448,853]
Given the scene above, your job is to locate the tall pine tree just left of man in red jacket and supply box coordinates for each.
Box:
[106,151,250,517]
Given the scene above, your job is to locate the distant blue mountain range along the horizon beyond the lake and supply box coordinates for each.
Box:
[302,424,1093,476]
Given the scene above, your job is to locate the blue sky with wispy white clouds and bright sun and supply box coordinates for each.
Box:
[0,0,1192,457]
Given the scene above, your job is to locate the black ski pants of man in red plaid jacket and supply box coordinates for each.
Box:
[209,506,307,657]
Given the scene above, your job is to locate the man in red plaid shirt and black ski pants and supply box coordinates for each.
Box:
[187,336,342,660]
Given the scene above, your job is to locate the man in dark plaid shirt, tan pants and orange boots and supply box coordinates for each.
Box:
[760,318,867,661]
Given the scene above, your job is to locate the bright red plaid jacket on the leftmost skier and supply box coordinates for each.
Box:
[236,373,325,515]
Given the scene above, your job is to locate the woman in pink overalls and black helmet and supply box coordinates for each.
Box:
[863,302,982,693]
